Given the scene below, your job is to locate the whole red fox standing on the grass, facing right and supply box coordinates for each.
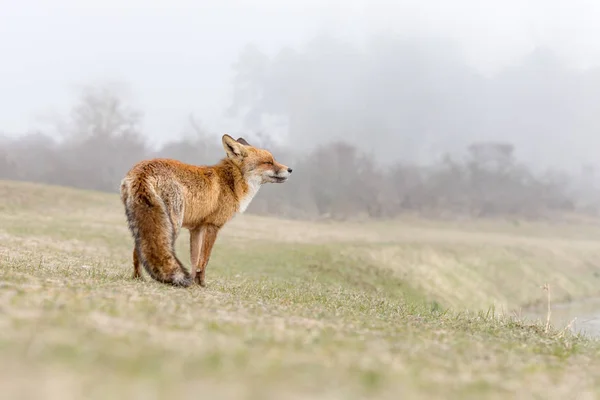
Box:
[121,134,292,287]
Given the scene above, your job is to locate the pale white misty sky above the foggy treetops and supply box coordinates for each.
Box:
[0,0,600,147]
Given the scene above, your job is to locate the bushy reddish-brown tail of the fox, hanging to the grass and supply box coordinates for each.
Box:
[121,180,192,287]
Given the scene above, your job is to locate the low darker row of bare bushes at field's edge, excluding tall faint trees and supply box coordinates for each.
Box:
[0,83,599,219]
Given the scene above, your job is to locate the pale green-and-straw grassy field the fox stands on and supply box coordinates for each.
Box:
[0,181,600,400]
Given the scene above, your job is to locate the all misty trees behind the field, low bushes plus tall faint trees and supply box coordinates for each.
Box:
[0,36,600,219]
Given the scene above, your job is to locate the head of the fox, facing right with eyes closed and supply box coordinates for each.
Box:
[222,134,292,184]
